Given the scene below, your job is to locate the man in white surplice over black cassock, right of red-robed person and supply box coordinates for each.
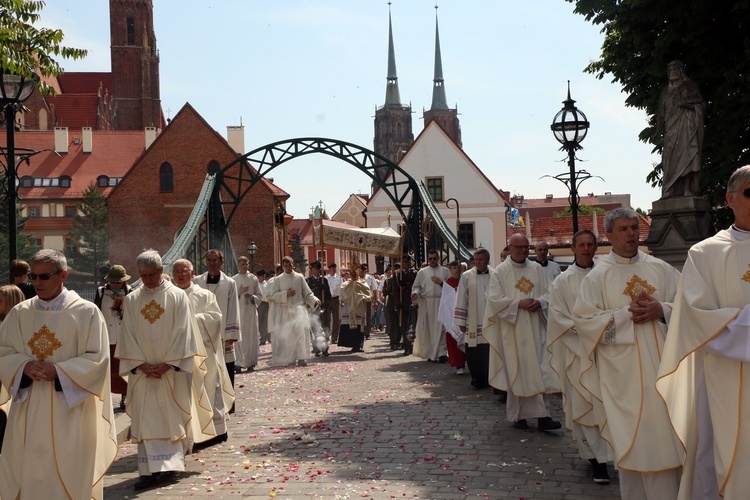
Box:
[453,248,495,389]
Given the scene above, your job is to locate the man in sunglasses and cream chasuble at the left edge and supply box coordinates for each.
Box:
[0,250,117,499]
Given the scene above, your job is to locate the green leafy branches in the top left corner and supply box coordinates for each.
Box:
[0,0,88,94]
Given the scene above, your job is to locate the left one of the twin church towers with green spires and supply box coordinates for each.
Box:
[373,5,414,183]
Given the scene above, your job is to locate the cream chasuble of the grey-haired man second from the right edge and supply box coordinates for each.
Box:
[573,252,683,472]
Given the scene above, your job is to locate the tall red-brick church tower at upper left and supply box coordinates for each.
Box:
[109,0,163,130]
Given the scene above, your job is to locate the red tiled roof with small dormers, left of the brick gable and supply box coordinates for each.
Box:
[16,130,146,200]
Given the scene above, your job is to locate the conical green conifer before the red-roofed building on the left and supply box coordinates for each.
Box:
[65,182,109,288]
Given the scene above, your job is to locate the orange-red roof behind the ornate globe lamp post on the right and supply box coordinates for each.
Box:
[524,215,651,247]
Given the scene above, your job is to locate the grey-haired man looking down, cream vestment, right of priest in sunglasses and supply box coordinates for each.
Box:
[115,250,215,489]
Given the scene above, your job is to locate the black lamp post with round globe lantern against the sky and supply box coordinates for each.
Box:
[544,80,591,234]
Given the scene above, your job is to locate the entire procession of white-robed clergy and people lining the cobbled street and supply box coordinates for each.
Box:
[0,166,750,500]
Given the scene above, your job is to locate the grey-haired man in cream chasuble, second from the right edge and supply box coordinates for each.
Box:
[573,208,684,500]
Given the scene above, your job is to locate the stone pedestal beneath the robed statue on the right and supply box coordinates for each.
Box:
[644,196,715,271]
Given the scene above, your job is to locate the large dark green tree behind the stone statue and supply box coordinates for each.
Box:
[566,0,750,227]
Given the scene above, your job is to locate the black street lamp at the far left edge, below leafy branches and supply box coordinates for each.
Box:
[0,68,39,270]
